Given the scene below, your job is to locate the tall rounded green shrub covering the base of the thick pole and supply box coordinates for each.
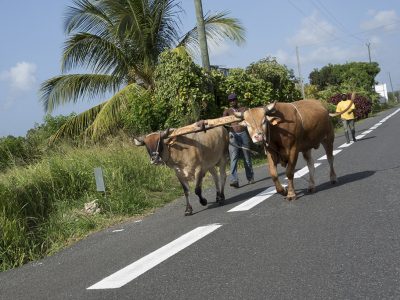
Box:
[152,51,220,128]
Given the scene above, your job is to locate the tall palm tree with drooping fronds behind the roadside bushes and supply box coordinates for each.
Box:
[39,0,244,138]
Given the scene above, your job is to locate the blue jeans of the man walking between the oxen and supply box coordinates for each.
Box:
[229,131,254,182]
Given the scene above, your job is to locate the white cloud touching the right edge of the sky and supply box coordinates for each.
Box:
[361,10,400,31]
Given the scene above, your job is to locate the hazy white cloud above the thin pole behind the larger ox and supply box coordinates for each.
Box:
[287,12,337,46]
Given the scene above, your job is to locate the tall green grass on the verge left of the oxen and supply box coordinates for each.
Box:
[0,144,182,270]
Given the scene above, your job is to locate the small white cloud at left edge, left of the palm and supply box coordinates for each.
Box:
[0,61,36,92]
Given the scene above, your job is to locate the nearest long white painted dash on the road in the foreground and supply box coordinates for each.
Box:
[87,224,222,290]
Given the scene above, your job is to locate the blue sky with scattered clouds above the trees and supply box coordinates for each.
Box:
[0,0,400,137]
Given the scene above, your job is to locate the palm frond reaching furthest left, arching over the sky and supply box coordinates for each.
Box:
[39,74,122,112]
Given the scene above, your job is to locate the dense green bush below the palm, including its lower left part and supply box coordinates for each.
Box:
[123,49,219,134]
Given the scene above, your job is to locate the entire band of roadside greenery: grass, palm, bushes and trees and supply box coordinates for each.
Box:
[0,0,399,271]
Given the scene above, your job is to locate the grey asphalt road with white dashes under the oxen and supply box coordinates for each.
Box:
[0,108,400,300]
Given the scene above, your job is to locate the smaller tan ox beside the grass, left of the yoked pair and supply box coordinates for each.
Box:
[134,127,229,215]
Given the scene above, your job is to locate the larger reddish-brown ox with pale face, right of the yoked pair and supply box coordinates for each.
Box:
[235,100,337,200]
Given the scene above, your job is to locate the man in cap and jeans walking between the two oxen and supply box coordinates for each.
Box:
[223,94,254,188]
